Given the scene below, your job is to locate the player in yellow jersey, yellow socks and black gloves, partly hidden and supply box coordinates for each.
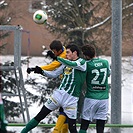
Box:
[27,40,68,133]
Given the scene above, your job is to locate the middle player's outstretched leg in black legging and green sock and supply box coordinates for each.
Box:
[21,106,51,133]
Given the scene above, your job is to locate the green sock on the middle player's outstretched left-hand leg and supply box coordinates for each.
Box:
[21,118,39,133]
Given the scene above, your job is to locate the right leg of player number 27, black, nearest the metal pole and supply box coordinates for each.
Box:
[96,120,105,133]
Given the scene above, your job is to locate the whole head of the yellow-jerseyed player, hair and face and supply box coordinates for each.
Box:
[49,40,63,56]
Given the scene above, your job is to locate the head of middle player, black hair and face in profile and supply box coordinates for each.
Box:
[66,43,79,60]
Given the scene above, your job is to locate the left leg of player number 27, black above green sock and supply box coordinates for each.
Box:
[79,119,90,133]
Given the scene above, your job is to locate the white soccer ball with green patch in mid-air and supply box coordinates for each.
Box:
[33,10,48,24]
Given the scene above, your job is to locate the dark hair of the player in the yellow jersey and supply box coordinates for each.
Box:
[49,40,63,52]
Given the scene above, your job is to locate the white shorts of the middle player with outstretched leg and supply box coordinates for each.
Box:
[45,89,79,119]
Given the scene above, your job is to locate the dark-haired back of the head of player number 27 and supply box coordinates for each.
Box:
[81,45,96,58]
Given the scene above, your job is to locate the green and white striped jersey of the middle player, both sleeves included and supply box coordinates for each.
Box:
[43,57,86,97]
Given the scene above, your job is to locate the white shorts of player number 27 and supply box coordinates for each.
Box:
[82,98,109,121]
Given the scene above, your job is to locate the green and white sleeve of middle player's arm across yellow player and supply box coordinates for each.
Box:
[57,57,86,71]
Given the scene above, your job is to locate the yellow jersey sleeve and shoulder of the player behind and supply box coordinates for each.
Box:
[41,47,66,71]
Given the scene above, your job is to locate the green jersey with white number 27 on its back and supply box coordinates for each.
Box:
[85,58,110,100]
